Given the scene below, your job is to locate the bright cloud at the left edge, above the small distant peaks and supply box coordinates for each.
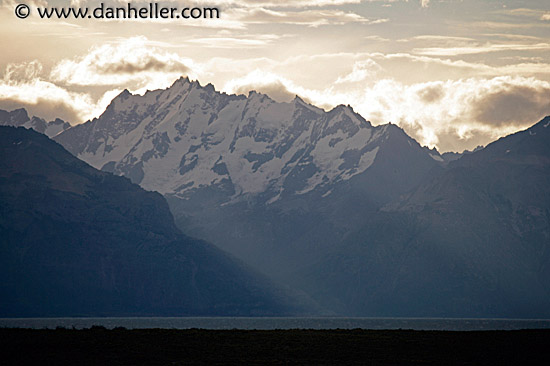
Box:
[0,61,95,124]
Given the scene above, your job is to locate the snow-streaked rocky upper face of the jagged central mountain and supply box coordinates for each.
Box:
[56,78,424,202]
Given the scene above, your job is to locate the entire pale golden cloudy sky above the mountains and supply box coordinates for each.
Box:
[0,0,550,152]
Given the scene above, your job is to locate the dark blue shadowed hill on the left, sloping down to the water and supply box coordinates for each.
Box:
[0,127,302,317]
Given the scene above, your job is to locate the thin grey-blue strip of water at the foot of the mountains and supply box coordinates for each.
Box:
[0,317,550,330]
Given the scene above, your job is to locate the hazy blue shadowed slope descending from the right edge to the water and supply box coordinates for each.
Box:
[296,117,550,318]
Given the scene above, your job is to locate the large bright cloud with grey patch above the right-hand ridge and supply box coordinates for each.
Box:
[348,76,550,151]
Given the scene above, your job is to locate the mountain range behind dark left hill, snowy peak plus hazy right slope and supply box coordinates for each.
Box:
[2,78,550,318]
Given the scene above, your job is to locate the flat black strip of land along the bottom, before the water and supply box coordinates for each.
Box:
[0,327,550,365]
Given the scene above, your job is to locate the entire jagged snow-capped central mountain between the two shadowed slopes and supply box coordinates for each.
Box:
[55,78,443,279]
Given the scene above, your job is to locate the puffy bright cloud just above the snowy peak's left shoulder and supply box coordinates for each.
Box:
[50,37,196,89]
